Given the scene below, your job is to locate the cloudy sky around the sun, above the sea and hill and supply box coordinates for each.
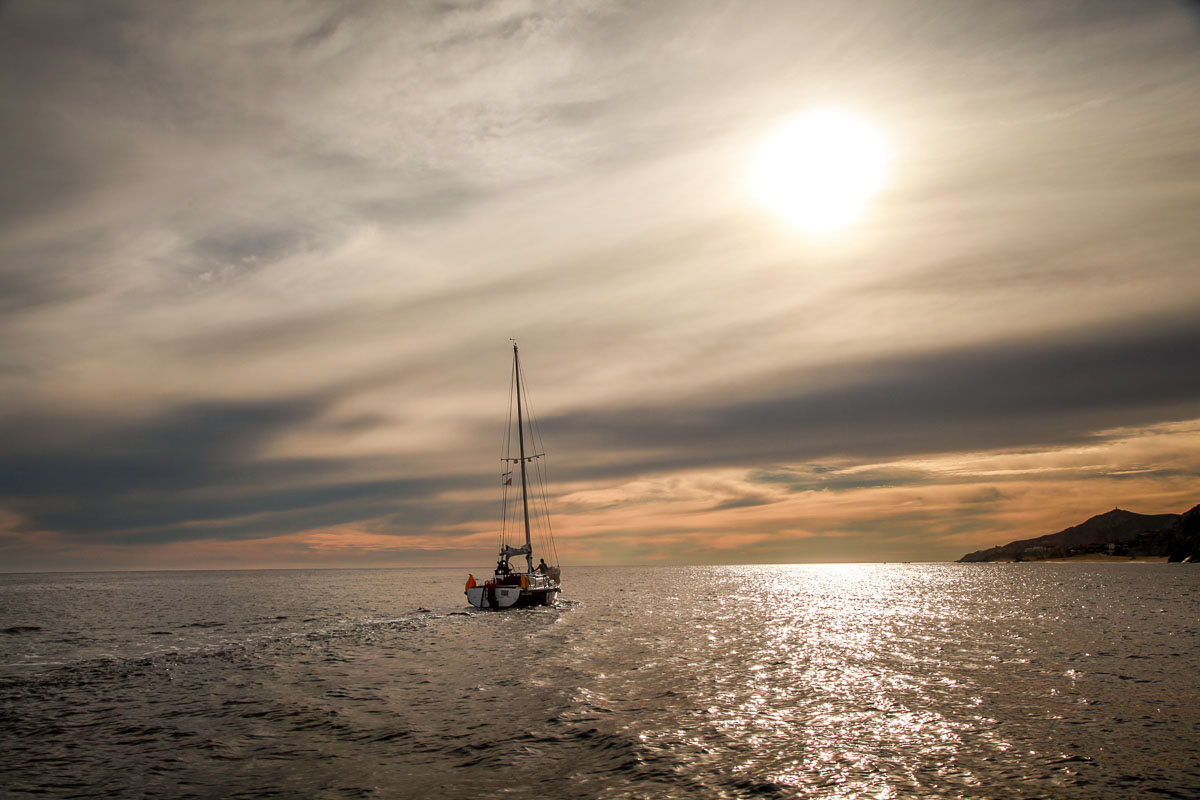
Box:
[0,0,1200,571]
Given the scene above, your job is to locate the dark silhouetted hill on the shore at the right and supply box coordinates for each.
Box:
[959,505,1200,564]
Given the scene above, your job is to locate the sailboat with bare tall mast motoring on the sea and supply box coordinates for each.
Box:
[464,341,560,610]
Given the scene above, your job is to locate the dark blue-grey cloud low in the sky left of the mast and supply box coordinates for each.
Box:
[0,398,480,543]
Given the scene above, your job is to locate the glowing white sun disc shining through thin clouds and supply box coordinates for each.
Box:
[750,109,888,233]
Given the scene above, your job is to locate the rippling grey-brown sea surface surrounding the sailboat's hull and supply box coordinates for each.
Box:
[0,564,1200,799]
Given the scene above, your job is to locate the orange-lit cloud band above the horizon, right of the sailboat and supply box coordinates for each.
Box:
[549,420,1200,564]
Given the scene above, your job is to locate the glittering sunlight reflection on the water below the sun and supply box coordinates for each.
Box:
[554,565,1196,798]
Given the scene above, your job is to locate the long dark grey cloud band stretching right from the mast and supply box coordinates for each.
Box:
[542,311,1200,476]
